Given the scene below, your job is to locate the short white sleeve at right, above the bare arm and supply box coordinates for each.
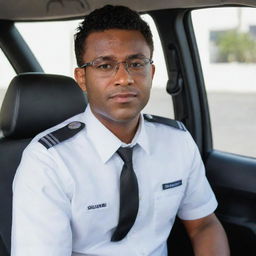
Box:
[178,134,217,220]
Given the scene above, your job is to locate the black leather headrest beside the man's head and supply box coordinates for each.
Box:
[0,73,86,139]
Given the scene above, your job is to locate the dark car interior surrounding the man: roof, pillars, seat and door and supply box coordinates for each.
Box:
[0,0,256,256]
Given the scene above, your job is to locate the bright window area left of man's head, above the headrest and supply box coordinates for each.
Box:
[16,20,80,77]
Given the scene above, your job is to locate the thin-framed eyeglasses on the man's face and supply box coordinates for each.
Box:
[80,56,153,77]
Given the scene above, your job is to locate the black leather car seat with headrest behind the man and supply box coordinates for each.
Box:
[0,73,86,256]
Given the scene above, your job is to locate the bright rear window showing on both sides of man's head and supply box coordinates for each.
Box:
[16,15,174,118]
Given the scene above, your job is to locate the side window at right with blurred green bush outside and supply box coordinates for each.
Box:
[192,7,256,157]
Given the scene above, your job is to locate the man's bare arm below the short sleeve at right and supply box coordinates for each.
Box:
[182,214,230,256]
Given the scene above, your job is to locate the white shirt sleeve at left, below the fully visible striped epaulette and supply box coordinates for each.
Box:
[11,143,72,256]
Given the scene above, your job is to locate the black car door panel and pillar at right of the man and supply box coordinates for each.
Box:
[153,7,256,256]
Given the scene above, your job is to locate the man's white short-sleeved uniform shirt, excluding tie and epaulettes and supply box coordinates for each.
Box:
[11,107,217,256]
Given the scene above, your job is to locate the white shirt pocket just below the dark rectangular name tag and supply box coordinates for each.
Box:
[154,184,185,234]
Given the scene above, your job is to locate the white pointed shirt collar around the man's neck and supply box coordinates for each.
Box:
[85,105,150,163]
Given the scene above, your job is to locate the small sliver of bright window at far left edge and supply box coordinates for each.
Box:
[0,48,16,106]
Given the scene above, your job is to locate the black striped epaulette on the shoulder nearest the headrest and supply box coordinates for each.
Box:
[38,121,85,149]
